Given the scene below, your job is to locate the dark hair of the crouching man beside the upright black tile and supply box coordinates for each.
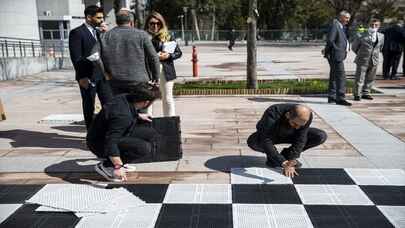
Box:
[127,83,160,103]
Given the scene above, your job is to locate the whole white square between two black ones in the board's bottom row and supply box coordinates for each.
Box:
[232,204,313,228]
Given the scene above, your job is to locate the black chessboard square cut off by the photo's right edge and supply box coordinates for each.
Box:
[360,185,405,206]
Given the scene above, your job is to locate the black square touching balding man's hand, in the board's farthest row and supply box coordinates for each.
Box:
[292,169,355,185]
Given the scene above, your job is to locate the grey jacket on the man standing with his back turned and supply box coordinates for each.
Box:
[101,26,160,83]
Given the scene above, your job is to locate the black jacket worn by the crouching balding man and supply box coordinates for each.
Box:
[256,104,313,159]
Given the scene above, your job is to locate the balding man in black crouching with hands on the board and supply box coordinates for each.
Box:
[247,103,327,177]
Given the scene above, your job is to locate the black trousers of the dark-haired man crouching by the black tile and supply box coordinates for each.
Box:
[87,124,160,166]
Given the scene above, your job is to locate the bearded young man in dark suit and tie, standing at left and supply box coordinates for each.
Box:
[69,5,112,129]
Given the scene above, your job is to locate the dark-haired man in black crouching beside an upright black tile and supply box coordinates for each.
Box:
[86,84,159,181]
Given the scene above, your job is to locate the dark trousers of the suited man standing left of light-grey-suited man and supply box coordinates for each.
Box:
[328,59,346,101]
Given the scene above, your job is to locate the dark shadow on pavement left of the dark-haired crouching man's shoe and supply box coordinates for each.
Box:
[45,158,105,184]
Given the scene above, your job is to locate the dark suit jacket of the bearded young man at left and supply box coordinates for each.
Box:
[69,24,103,81]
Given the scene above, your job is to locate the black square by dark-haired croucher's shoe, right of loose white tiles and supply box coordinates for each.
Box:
[107,184,169,203]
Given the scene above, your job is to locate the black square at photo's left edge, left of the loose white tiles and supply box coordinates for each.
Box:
[0,185,43,204]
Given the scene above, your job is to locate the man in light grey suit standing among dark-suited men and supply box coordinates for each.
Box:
[352,19,384,101]
